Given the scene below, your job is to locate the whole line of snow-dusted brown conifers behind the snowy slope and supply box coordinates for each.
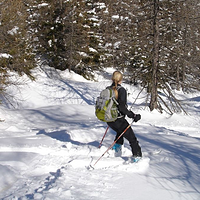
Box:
[0,0,200,113]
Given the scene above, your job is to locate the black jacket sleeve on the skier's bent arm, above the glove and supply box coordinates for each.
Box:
[118,87,135,118]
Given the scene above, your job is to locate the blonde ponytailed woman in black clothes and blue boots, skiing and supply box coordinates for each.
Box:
[107,71,142,159]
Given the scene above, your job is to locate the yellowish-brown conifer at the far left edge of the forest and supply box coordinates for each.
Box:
[0,0,35,99]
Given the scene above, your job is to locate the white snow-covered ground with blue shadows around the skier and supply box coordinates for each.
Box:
[0,66,200,200]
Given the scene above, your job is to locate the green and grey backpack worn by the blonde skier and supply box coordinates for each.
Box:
[95,87,118,122]
